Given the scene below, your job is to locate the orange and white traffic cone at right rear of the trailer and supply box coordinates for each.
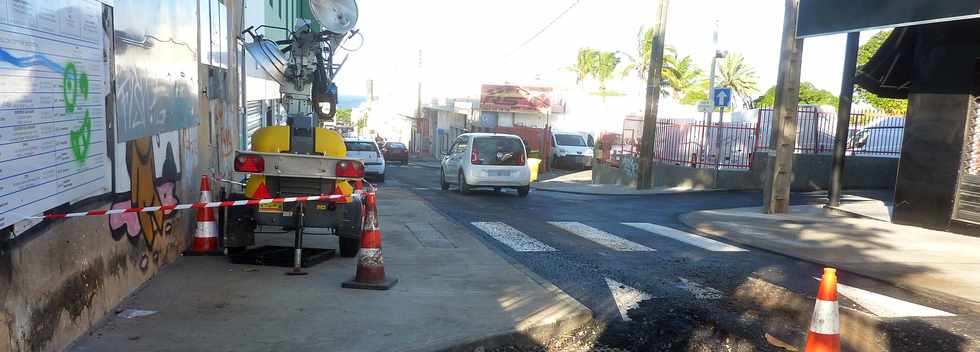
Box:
[341,190,398,290]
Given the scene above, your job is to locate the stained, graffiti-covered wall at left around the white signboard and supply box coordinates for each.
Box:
[0,0,239,352]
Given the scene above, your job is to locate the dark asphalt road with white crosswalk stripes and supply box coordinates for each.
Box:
[384,165,976,350]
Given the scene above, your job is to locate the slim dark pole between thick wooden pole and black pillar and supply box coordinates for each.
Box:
[827,32,861,207]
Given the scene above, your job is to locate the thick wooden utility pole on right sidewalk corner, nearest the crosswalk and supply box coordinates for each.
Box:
[763,0,803,214]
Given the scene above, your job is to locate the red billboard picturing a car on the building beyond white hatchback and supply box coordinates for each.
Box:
[480,84,551,113]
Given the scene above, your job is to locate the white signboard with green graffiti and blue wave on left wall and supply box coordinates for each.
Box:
[0,0,109,228]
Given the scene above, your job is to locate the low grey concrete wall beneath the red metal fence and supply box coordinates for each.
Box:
[592,153,898,191]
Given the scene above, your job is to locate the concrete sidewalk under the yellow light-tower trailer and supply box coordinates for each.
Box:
[70,188,592,351]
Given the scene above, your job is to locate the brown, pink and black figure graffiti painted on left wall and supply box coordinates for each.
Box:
[109,131,181,271]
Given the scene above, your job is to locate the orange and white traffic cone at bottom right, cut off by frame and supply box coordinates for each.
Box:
[805,268,840,352]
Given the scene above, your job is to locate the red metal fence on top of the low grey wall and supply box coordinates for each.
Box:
[596,106,905,169]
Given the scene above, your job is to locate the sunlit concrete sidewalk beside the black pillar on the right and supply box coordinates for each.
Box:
[680,204,980,311]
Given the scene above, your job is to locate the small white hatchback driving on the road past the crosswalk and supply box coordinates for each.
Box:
[440,133,531,197]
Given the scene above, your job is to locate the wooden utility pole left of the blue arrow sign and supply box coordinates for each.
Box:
[636,0,670,189]
